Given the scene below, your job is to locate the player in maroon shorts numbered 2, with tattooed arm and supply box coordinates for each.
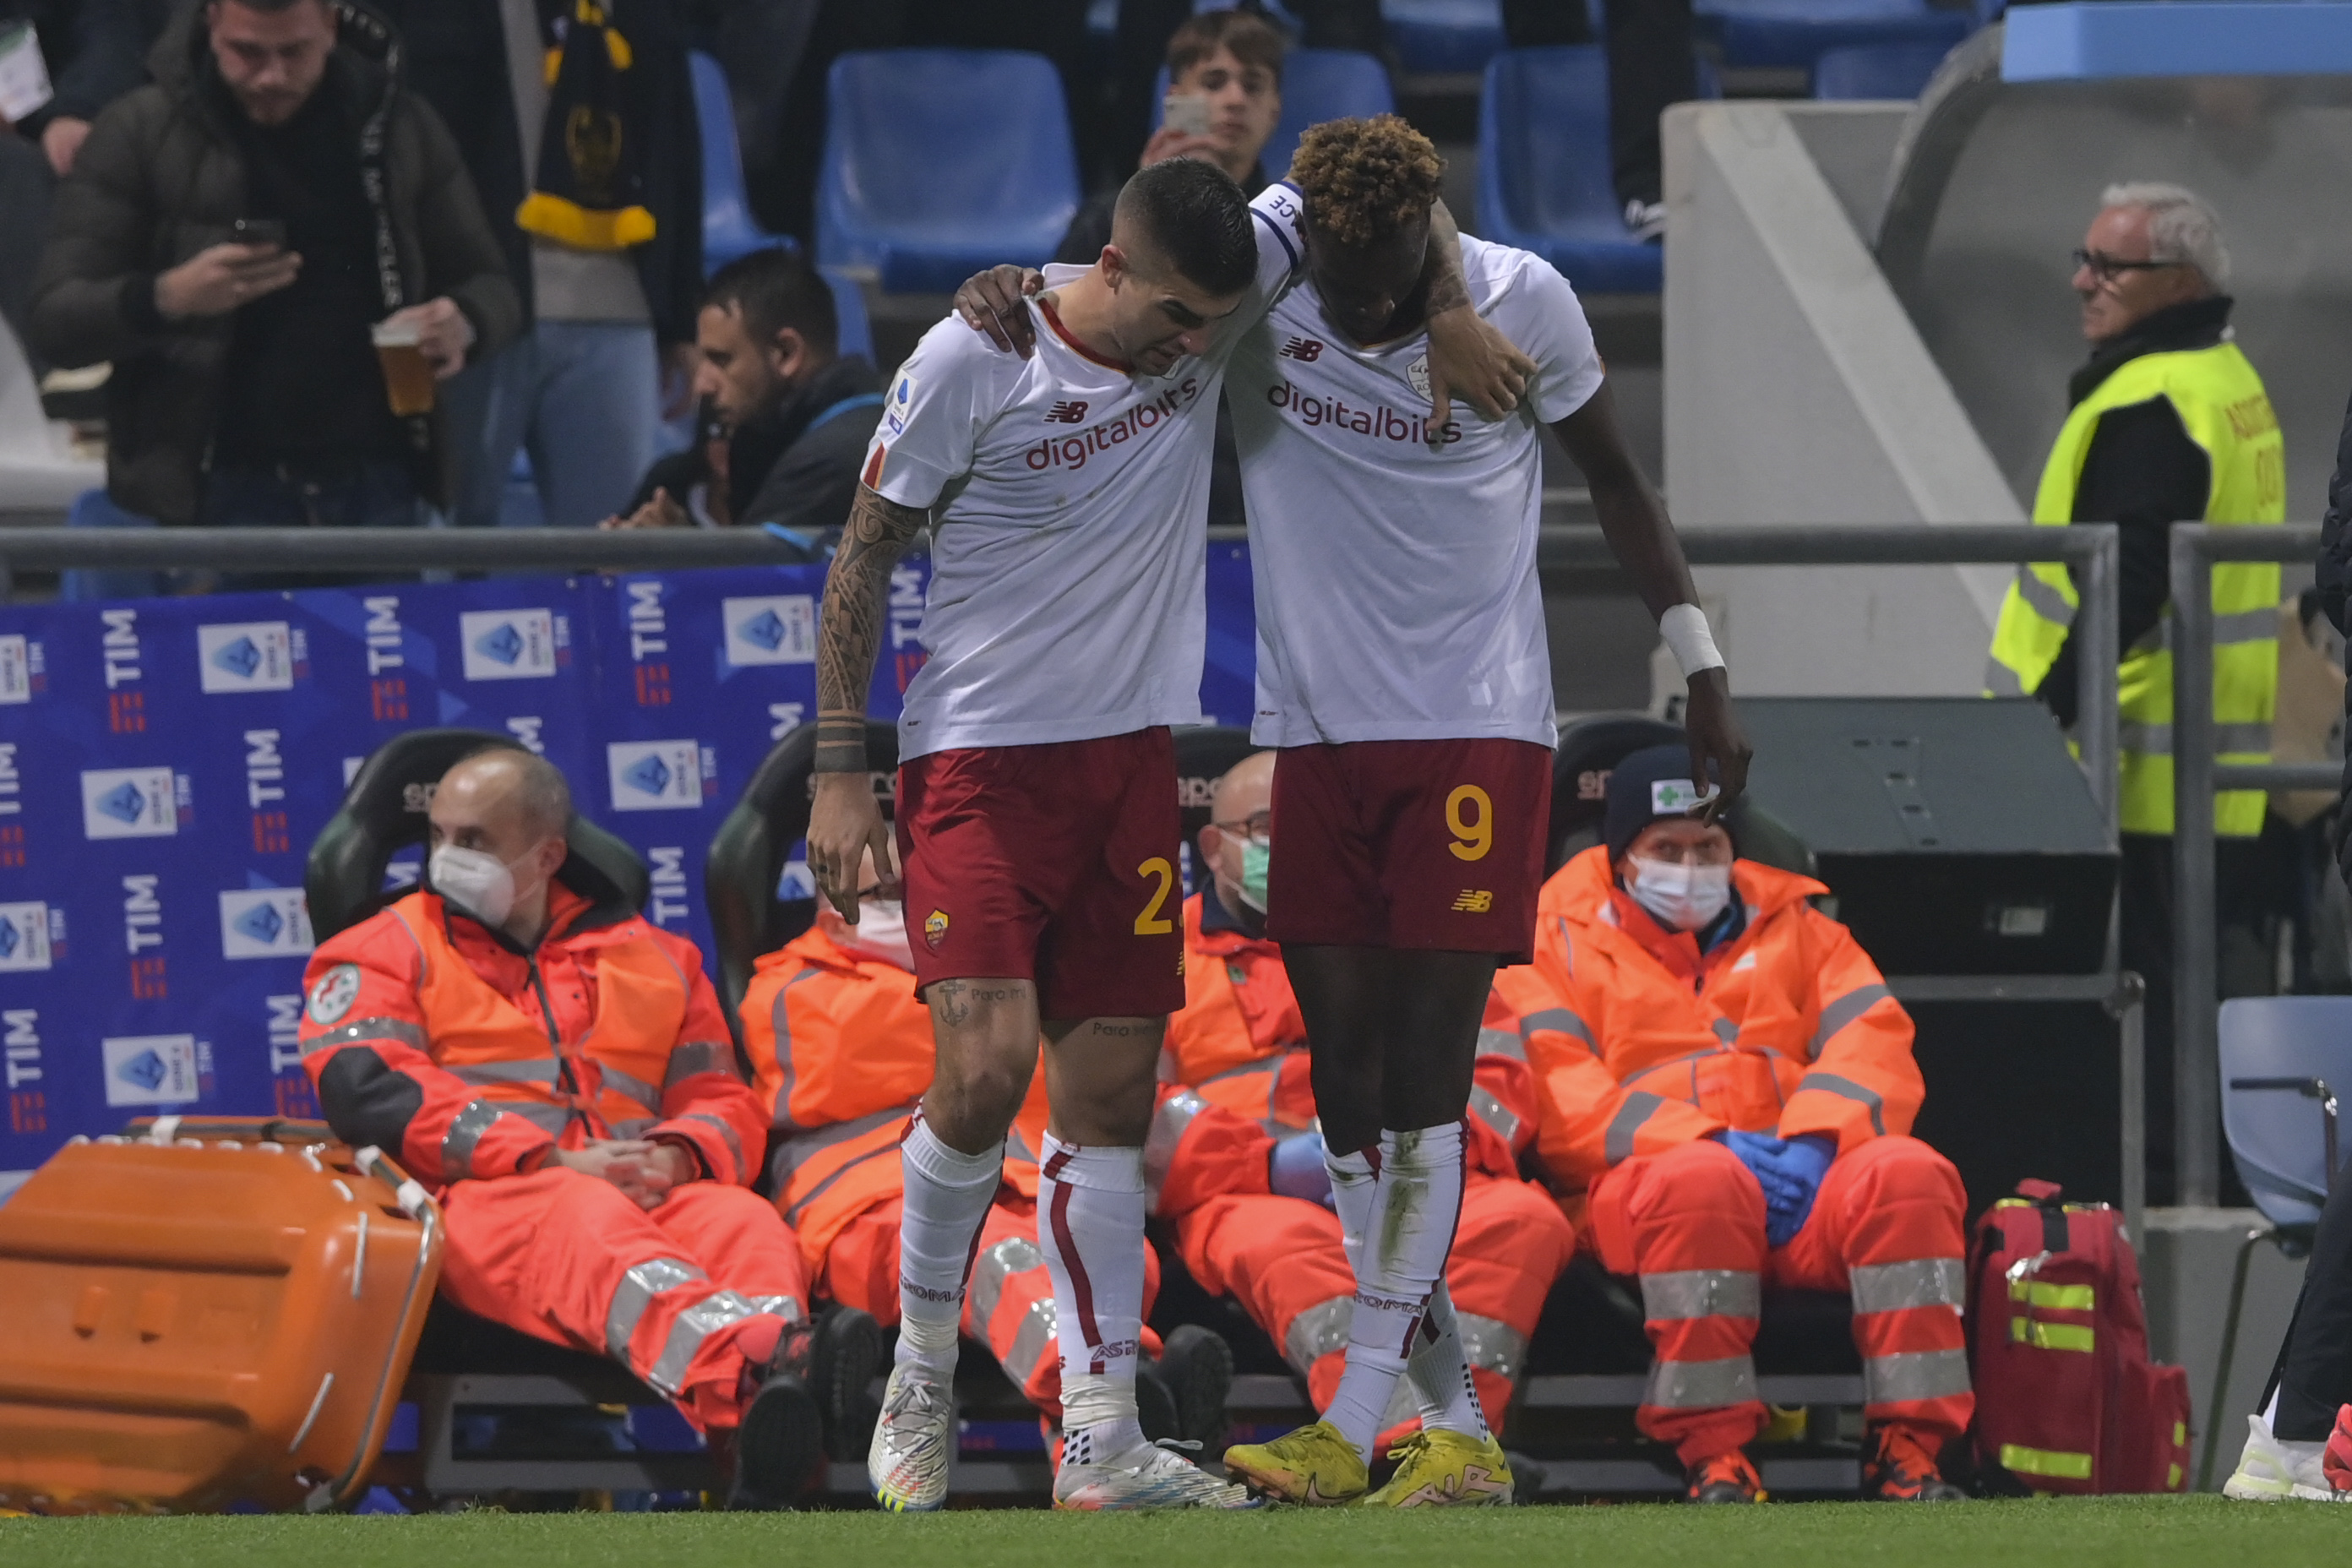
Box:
[809,160,1512,1509]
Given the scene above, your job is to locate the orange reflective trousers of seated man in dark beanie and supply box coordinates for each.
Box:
[1592,1135,1976,1465]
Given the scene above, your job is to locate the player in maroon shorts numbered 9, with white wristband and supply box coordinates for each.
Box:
[966,115,1748,1507]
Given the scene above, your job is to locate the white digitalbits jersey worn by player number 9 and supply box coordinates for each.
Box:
[1228,237,1602,745]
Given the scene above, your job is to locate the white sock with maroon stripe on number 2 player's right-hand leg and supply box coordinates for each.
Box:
[1037,1133,1148,1465]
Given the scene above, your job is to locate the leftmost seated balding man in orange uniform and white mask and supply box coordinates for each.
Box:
[301,745,879,1507]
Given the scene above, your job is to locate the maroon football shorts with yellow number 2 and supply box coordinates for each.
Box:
[898,727,1183,1021]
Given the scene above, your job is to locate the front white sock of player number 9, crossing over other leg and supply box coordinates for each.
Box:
[1324,1121,1463,1465]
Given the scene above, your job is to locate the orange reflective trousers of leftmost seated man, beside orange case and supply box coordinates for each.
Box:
[440,1166,809,1432]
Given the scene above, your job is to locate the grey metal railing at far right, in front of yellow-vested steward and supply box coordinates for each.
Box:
[2171,525,2343,1206]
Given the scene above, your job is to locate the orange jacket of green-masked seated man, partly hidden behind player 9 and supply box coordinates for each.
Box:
[1146,893,1536,1180]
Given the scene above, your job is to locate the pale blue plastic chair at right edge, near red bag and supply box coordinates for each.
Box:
[2197,997,2352,1490]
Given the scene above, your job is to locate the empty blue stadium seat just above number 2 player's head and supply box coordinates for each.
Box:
[816,49,1077,294]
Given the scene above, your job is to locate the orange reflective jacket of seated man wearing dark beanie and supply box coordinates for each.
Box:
[1498,847,1924,1192]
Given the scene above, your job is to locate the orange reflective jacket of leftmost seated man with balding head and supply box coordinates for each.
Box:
[301,881,767,1184]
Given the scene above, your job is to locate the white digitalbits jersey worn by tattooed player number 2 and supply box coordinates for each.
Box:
[863,186,1301,760]
